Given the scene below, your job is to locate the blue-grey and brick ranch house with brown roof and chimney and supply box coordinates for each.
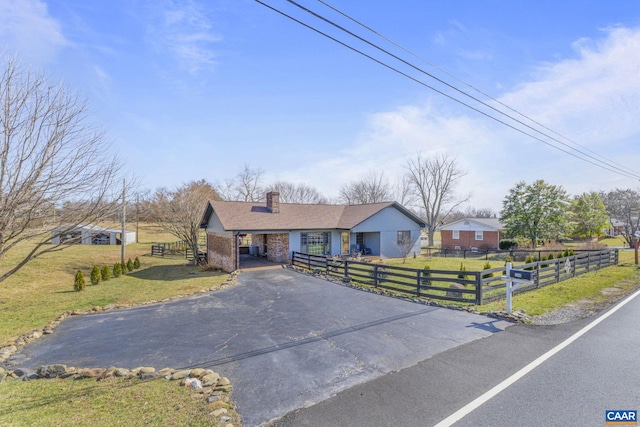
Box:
[200,191,427,272]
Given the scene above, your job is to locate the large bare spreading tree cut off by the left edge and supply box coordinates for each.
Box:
[0,58,121,282]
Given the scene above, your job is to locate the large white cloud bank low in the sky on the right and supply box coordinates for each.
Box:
[304,28,640,211]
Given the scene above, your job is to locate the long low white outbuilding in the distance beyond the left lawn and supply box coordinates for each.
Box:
[51,224,136,245]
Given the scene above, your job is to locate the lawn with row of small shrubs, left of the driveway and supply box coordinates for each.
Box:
[0,226,228,344]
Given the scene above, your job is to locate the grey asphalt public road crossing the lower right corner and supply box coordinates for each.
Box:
[272,290,640,427]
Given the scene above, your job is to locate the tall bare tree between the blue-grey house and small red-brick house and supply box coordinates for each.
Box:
[407,154,469,246]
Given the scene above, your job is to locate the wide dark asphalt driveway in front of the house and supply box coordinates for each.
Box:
[10,269,508,426]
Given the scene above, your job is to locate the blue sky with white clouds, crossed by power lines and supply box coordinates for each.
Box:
[0,0,640,211]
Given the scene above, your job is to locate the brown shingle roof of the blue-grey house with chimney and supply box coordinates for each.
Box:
[201,200,425,231]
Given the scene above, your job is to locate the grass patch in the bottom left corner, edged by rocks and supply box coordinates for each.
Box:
[0,379,226,427]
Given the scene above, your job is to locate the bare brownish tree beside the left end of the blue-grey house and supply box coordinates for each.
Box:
[149,180,220,257]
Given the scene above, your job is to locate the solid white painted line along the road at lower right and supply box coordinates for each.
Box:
[434,290,640,427]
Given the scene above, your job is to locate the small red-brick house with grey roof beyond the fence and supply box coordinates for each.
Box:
[440,218,504,250]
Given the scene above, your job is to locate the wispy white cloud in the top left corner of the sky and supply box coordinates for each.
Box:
[0,0,69,64]
